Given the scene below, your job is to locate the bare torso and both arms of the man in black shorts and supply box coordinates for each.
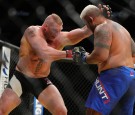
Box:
[16,26,92,78]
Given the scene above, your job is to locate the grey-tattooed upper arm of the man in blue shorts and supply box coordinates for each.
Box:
[94,28,111,49]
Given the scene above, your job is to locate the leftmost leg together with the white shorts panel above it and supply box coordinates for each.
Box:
[0,75,22,115]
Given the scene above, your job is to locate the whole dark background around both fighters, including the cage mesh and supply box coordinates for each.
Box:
[0,0,135,115]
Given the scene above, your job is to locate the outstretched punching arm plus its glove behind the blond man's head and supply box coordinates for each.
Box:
[61,4,112,46]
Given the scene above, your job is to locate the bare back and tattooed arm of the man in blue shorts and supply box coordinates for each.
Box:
[87,19,133,73]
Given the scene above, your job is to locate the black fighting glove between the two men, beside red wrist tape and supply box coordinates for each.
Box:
[72,46,86,64]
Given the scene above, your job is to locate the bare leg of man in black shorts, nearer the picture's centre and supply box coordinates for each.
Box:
[38,85,67,115]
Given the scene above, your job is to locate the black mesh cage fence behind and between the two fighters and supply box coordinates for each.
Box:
[0,41,134,115]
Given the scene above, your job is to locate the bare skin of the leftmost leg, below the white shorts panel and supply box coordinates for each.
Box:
[0,88,21,115]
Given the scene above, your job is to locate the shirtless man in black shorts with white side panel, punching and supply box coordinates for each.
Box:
[0,4,112,115]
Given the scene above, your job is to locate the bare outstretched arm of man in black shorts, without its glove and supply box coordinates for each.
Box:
[61,26,93,46]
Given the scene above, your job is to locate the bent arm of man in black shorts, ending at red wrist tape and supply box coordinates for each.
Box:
[25,26,66,61]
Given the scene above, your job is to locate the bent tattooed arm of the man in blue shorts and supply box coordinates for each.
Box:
[86,25,112,64]
